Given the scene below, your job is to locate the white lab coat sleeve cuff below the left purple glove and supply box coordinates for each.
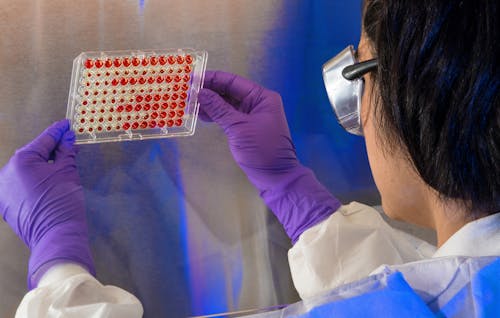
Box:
[16,263,143,318]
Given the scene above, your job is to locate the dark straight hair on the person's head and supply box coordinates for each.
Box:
[363,0,500,217]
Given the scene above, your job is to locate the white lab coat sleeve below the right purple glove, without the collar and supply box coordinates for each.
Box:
[288,202,436,299]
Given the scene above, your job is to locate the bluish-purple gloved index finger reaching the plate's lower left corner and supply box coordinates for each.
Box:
[19,119,69,161]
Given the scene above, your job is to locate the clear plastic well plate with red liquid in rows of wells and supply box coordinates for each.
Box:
[66,49,207,144]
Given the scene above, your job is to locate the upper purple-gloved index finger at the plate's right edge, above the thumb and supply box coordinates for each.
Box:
[203,71,262,102]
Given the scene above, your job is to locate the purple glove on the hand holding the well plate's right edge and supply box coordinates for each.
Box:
[198,71,340,243]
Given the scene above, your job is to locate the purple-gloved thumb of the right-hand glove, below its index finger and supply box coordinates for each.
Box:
[198,88,243,129]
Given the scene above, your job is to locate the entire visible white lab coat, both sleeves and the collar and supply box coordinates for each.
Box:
[16,202,500,318]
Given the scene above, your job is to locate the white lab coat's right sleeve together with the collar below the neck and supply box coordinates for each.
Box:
[288,202,500,299]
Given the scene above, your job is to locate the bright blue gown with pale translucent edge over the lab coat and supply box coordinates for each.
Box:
[252,257,500,318]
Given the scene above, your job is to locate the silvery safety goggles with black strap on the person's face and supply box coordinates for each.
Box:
[323,45,377,136]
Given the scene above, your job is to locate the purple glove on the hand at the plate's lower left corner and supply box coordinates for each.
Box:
[0,120,95,289]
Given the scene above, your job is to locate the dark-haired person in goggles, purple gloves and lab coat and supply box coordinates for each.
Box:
[0,0,500,317]
